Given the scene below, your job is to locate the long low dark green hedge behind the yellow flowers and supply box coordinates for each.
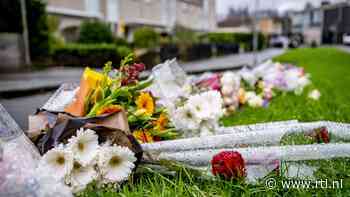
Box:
[53,44,131,67]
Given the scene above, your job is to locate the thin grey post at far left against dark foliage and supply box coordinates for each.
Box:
[20,0,31,65]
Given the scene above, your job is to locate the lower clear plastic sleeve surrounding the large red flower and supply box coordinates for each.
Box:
[146,143,350,183]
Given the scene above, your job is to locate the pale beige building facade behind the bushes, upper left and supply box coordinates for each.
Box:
[47,0,216,40]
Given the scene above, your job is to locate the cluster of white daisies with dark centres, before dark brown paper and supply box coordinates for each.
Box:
[38,129,136,193]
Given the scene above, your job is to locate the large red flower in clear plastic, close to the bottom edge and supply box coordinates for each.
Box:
[211,151,246,179]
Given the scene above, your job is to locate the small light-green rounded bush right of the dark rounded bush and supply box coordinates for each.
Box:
[134,27,159,48]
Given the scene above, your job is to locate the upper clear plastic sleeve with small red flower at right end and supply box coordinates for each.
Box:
[142,120,350,152]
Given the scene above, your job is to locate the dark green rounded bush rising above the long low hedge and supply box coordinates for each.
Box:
[79,21,113,44]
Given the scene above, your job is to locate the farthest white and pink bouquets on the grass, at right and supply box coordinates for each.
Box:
[194,61,321,114]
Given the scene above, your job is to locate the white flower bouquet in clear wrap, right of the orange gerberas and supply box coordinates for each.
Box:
[150,60,223,137]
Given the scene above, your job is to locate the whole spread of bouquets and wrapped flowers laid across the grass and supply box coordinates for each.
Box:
[10,53,350,195]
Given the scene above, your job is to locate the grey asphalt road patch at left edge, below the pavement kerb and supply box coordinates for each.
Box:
[0,92,53,130]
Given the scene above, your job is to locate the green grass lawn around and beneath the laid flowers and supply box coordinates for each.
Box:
[82,48,350,196]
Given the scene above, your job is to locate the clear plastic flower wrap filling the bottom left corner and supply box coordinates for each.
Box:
[0,105,72,197]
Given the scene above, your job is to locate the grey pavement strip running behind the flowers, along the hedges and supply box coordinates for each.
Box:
[0,49,284,96]
